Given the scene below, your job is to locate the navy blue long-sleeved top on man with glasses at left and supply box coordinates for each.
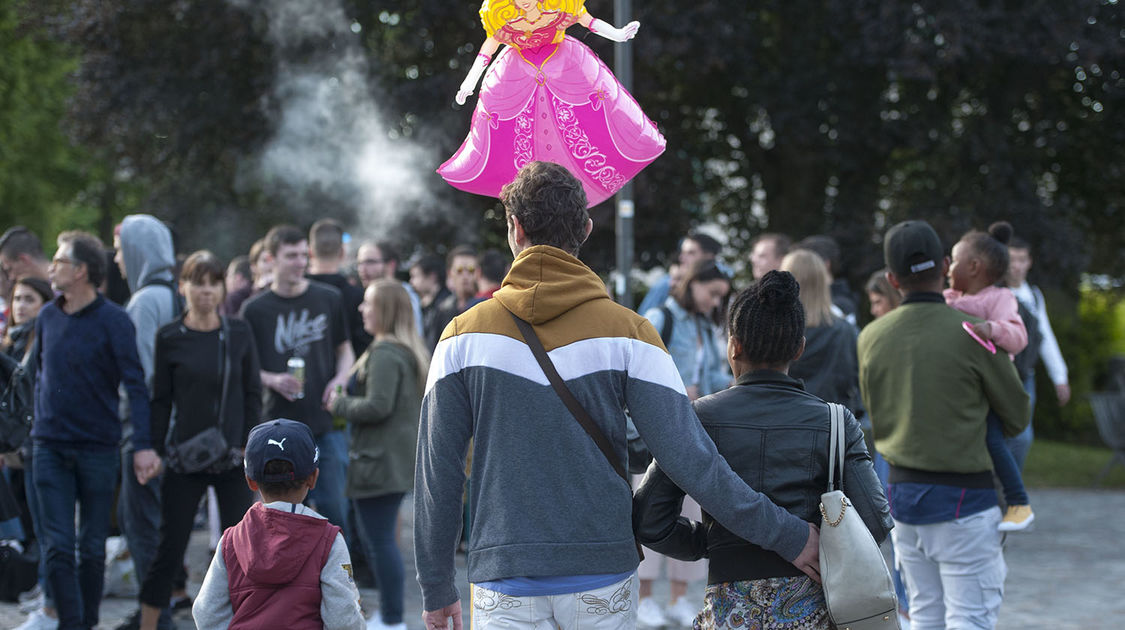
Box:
[32,295,152,450]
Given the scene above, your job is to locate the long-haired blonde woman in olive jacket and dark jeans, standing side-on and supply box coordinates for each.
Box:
[326,280,430,629]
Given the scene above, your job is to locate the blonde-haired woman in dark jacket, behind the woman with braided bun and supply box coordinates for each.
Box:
[781,250,863,416]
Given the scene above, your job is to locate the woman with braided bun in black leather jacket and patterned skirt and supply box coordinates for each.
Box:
[633,271,893,630]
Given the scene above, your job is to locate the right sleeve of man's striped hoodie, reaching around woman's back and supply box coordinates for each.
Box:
[626,337,809,561]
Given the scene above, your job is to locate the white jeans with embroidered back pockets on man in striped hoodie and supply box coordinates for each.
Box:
[473,573,637,630]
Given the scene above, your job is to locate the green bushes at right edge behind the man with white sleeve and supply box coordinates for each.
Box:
[1033,286,1125,444]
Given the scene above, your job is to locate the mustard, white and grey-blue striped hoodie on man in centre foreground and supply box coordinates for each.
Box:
[414,245,808,611]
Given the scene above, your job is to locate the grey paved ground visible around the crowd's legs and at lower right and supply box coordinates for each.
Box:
[0,489,1125,630]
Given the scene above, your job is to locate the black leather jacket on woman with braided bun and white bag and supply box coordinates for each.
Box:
[633,370,894,584]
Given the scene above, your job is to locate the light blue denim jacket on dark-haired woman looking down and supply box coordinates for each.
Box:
[645,297,731,396]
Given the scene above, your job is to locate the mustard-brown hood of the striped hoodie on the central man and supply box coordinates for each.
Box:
[493,245,610,325]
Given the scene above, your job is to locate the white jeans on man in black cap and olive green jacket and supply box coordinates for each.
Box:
[891,507,1008,630]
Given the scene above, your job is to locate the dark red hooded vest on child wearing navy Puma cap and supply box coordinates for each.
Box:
[223,503,340,630]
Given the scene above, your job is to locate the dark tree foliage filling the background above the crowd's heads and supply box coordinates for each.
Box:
[0,0,1125,285]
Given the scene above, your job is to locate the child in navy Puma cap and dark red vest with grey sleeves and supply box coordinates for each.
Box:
[191,420,366,630]
